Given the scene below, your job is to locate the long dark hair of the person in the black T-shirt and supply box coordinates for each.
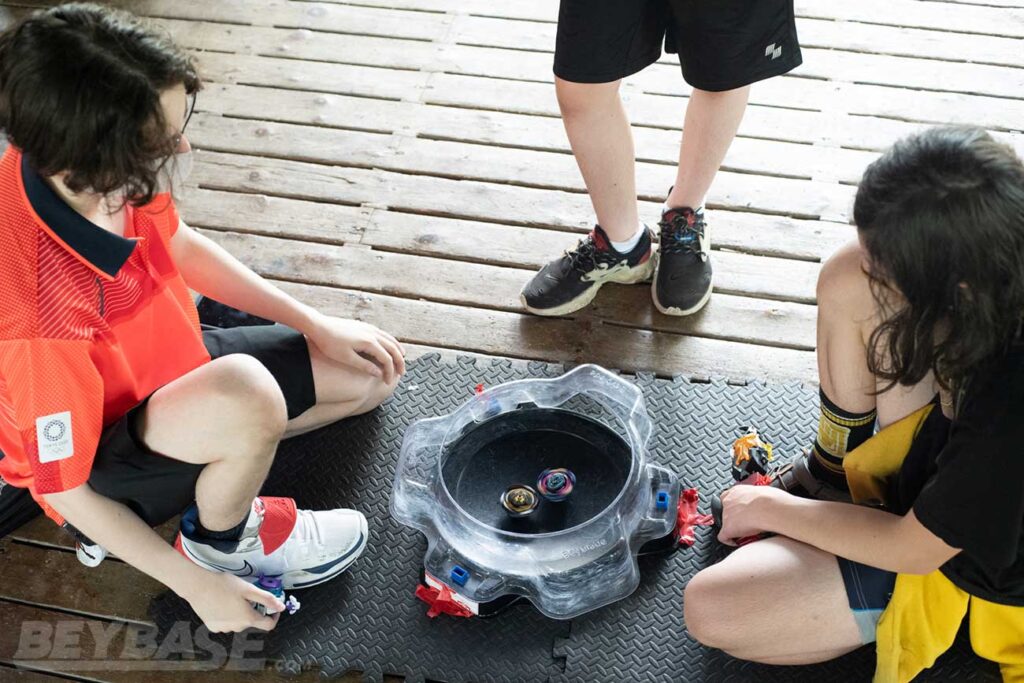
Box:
[854,127,1024,389]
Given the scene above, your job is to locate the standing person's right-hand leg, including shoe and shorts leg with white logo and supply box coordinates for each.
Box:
[651,0,801,315]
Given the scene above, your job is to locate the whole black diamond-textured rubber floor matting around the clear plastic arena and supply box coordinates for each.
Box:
[152,356,997,683]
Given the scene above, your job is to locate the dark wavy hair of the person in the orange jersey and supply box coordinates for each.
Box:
[0,3,201,206]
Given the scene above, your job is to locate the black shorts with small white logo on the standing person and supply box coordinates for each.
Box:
[555,0,803,91]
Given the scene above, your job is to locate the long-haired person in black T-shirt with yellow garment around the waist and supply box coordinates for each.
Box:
[684,128,1024,683]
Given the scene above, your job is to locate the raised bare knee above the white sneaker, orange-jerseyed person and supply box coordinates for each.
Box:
[208,353,288,440]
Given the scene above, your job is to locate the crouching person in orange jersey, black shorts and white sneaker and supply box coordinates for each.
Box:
[0,4,404,631]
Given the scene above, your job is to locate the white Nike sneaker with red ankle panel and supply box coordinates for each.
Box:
[174,497,368,590]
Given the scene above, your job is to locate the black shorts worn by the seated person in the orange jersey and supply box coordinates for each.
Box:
[71,325,316,532]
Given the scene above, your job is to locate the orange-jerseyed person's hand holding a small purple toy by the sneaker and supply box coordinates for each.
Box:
[182,570,285,633]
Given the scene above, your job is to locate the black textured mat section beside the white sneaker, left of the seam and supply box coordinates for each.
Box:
[152,356,569,683]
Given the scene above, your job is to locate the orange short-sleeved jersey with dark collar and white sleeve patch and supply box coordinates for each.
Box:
[0,146,210,519]
